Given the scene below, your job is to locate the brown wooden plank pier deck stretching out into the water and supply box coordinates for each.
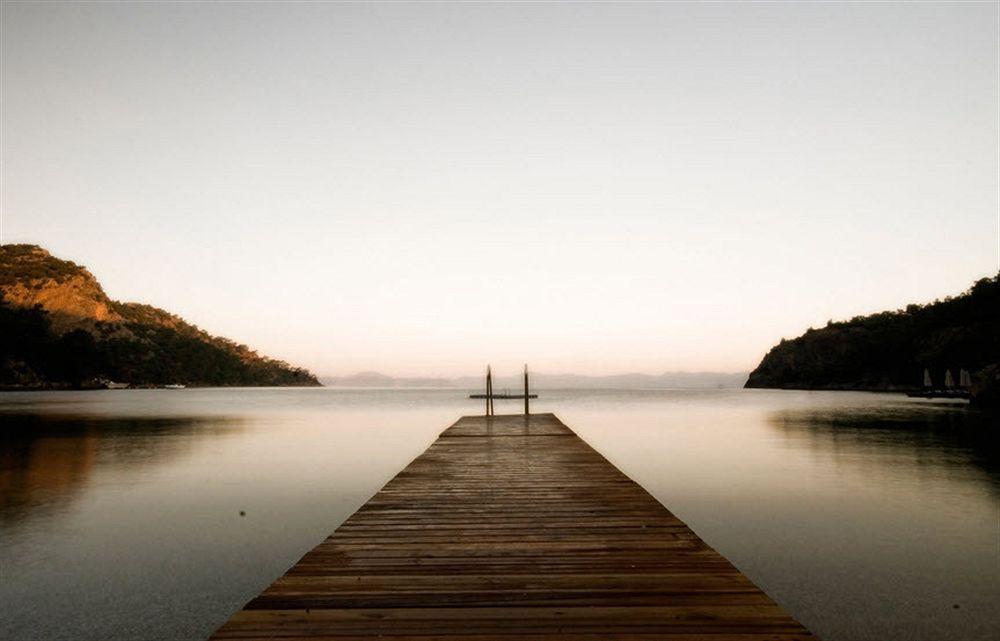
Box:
[212,414,813,641]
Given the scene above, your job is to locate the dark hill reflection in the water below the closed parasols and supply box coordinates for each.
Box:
[767,402,1000,492]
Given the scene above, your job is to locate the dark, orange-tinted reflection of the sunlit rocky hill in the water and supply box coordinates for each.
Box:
[0,414,240,524]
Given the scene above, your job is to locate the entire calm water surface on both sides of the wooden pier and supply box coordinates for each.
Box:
[0,389,1000,641]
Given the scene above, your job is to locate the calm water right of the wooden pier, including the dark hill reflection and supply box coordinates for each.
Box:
[563,391,1000,641]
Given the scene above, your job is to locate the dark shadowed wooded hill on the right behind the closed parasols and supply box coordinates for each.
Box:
[746,274,1000,390]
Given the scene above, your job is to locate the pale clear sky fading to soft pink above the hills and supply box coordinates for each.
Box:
[0,2,1000,376]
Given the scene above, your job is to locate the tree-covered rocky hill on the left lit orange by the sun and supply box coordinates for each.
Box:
[0,245,319,388]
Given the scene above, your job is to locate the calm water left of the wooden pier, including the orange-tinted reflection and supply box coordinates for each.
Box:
[0,390,461,641]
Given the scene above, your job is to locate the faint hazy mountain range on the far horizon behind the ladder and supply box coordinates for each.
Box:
[320,372,747,390]
